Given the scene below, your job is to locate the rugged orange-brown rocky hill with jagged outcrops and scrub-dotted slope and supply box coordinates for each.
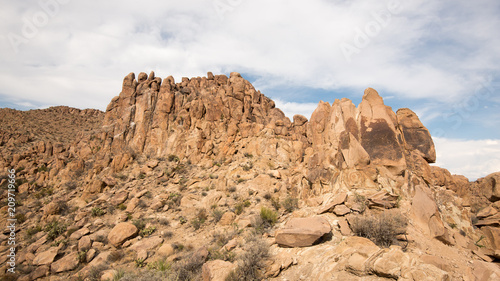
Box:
[0,72,500,281]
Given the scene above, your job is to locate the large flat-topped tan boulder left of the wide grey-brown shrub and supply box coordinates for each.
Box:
[276,217,332,247]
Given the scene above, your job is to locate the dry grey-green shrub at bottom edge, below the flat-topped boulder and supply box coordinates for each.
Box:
[225,235,269,281]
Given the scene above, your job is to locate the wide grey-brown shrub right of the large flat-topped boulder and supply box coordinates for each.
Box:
[349,210,408,247]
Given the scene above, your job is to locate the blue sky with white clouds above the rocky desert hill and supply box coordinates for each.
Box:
[0,0,500,179]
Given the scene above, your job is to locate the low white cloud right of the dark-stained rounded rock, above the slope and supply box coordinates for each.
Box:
[433,137,500,180]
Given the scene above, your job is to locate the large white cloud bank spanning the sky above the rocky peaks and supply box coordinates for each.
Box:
[0,0,500,109]
